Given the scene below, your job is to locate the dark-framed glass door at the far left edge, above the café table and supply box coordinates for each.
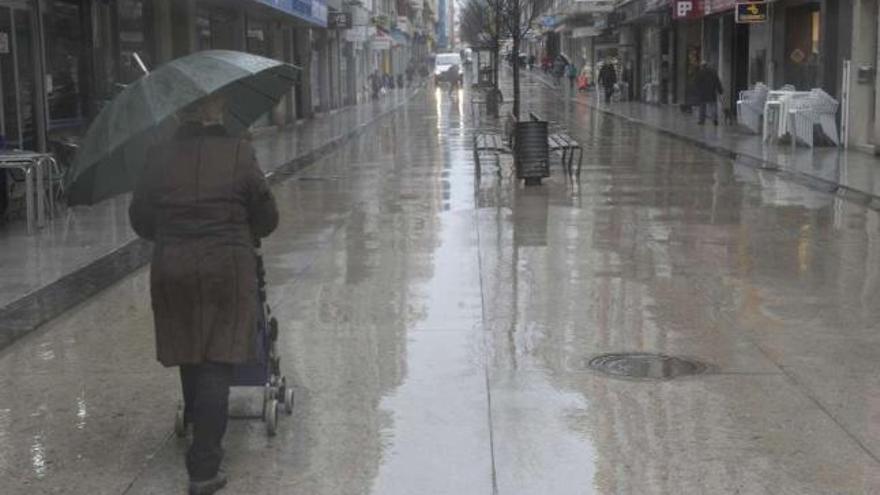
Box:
[0,2,37,150]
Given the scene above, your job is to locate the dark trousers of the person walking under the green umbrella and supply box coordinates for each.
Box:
[180,363,233,481]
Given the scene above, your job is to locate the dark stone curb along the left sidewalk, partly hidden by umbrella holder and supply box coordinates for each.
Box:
[0,88,422,351]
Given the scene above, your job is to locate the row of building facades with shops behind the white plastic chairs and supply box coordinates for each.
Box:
[531,0,880,152]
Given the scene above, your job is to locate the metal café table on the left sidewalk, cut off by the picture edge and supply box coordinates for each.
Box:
[0,150,55,234]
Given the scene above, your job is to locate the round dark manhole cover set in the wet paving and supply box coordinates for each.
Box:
[589,352,709,380]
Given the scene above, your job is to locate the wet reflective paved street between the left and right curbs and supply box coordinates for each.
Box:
[0,75,880,495]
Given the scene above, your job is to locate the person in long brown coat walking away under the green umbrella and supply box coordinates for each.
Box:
[129,96,278,495]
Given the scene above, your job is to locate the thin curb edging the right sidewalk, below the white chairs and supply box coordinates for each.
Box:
[530,74,880,211]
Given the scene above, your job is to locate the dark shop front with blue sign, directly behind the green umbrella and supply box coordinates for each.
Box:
[0,0,327,157]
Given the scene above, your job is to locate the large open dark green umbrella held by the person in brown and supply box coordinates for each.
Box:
[66,50,299,205]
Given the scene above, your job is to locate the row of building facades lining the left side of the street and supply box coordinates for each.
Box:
[0,0,436,156]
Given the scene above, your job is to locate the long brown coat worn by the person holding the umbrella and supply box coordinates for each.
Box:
[129,124,278,366]
